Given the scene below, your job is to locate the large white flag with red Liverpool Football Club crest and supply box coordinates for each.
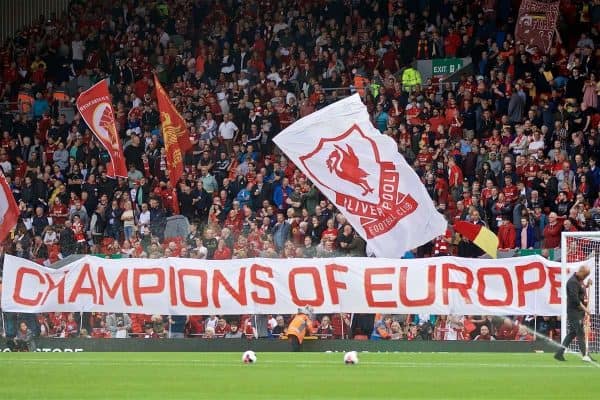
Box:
[273,94,447,257]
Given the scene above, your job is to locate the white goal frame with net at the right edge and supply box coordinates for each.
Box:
[560,232,600,353]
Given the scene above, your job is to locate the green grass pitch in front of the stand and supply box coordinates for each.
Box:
[0,353,600,400]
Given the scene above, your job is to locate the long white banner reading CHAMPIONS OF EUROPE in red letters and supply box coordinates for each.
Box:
[2,255,591,315]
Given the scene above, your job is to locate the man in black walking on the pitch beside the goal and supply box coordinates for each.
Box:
[554,265,592,361]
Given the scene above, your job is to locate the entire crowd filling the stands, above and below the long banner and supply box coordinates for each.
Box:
[0,0,600,340]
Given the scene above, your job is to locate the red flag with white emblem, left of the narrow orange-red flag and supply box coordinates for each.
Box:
[77,79,127,178]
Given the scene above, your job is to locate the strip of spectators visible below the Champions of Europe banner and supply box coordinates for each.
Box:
[0,312,560,341]
